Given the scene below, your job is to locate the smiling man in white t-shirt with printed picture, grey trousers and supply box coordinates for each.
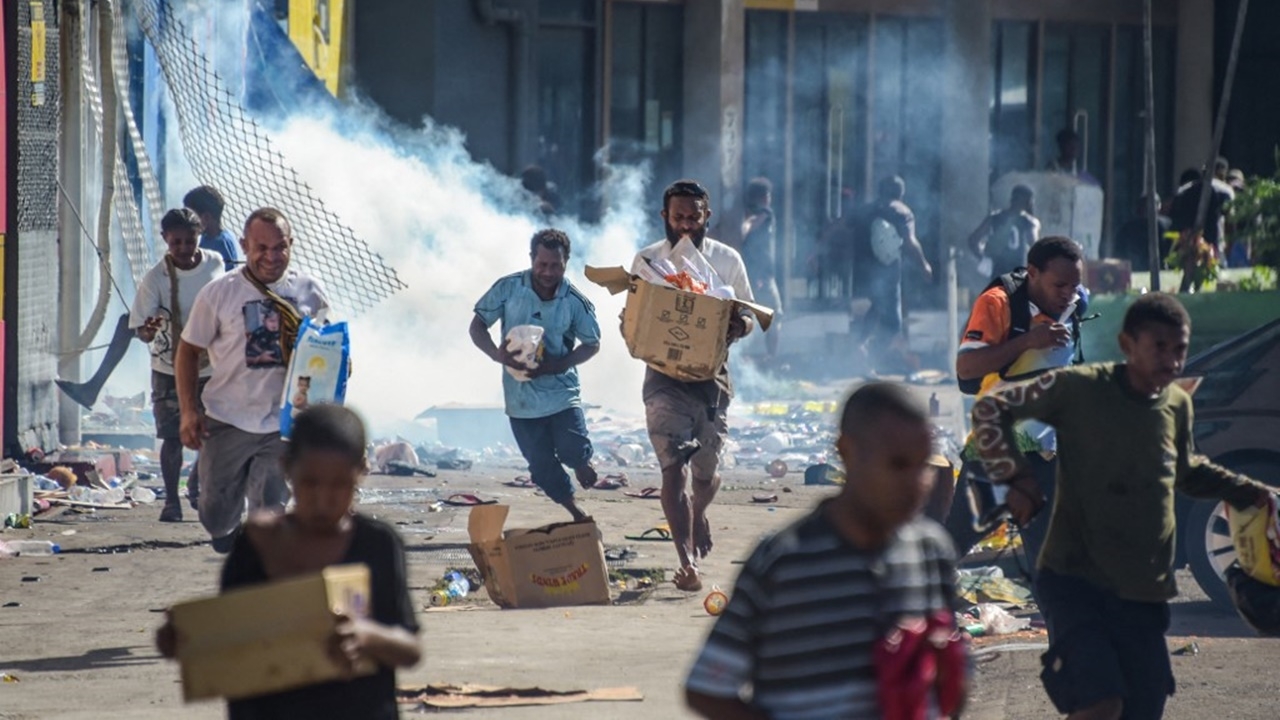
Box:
[177,208,329,553]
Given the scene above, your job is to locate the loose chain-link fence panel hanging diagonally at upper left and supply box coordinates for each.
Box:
[125,0,404,315]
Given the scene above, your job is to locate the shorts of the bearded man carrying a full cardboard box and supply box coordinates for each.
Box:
[644,386,731,480]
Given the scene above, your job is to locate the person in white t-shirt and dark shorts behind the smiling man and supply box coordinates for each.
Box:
[129,208,224,523]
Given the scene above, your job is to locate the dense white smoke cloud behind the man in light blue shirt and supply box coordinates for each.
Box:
[273,110,657,432]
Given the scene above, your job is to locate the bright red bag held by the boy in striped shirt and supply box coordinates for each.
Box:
[873,610,969,720]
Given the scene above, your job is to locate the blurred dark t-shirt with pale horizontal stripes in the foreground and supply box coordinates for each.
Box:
[686,503,955,720]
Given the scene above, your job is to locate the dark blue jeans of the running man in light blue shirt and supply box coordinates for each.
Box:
[509,407,593,505]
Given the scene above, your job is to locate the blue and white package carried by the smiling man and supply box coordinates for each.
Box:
[280,318,351,439]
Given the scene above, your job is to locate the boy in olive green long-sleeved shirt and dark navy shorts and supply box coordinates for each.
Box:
[973,292,1270,720]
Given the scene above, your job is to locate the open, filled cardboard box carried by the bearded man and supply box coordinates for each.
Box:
[585,265,773,382]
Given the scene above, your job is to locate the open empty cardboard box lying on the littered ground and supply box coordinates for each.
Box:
[467,505,609,607]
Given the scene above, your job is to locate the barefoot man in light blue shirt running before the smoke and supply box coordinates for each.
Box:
[471,229,600,520]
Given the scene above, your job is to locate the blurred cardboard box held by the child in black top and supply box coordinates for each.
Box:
[170,564,375,702]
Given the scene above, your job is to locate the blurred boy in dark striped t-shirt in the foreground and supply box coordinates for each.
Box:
[686,383,963,720]
